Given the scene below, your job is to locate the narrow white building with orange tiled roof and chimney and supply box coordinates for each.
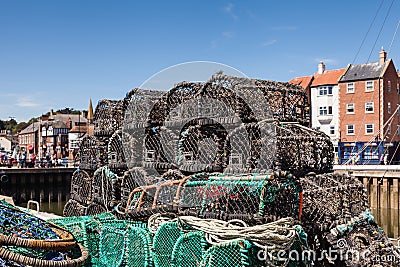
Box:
[311,62,345,163]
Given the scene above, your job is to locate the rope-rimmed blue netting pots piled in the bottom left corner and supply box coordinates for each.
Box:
[0,201,87,266]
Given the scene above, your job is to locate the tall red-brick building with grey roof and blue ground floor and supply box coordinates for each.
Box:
[338,49,400,164]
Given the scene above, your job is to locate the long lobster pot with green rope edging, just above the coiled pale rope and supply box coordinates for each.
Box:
[179,172,302,224]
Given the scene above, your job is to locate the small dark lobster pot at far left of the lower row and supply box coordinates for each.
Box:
[71,169,93,205]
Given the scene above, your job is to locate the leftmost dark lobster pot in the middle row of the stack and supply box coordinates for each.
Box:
[79,135,107,171]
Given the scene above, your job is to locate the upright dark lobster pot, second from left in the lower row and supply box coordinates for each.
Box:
[92,166,118,210]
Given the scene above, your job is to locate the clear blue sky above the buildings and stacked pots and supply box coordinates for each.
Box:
[0,0,400,121]
